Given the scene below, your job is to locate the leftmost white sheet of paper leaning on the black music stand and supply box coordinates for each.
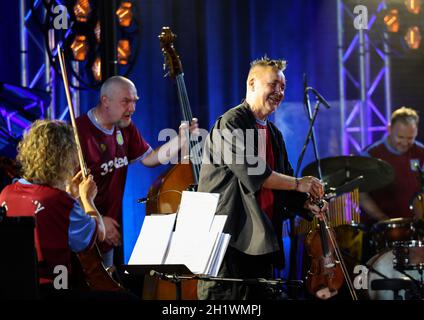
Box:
[128,213,176,264]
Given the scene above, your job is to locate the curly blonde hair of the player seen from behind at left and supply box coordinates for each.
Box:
[17,120,78,186]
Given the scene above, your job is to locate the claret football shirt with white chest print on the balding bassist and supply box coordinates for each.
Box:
[76,110,152,252]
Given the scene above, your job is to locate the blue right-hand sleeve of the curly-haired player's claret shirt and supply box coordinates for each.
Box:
[68,201,97,252]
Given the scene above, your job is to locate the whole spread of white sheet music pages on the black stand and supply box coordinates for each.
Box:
[128,191,230,276]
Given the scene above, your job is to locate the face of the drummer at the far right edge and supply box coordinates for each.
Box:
[388,121,418,153]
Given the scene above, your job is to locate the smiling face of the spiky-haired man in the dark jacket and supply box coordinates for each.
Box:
[246,66,286,119]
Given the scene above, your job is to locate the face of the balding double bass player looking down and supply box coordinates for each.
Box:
[102,83,138,128]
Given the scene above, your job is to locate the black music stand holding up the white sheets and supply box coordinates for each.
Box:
[122,264,194,300]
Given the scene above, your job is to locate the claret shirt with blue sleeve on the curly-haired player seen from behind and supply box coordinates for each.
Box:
[0,179,97,283]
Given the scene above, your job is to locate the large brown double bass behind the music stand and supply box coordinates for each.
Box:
[143,27,201,300]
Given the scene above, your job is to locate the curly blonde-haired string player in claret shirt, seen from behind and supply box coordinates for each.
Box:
[0,120,105,285]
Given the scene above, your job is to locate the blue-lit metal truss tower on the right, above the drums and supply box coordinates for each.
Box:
[337,0,392,154]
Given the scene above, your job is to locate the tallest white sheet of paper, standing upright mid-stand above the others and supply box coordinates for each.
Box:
[175,191,219,233]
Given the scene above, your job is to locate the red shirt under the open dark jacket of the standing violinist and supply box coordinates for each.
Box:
[256,120,275,221]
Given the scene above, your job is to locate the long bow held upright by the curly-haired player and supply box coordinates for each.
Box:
[57,44,88,179]
